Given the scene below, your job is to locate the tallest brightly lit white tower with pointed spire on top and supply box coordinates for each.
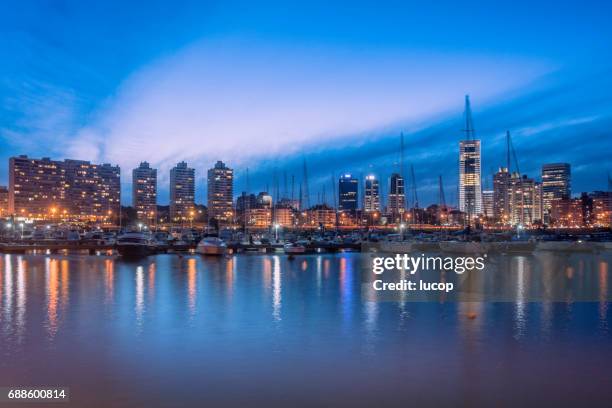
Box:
[459,95,482,218]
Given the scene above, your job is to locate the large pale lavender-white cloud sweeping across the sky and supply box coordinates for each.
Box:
[70,39,550,201]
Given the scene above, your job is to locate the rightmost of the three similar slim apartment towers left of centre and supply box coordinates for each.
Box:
[208,161,234,223]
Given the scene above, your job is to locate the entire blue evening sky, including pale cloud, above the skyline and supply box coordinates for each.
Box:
[0,1,612,204]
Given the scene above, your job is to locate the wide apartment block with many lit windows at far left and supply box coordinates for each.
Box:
[9,156,121,222]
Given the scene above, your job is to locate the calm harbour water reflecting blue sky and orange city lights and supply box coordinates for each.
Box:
[0,253,612,407]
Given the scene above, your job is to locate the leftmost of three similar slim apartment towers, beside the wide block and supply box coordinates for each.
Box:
[132,162,157,220]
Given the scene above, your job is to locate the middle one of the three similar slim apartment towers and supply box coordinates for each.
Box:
[170,161,195,221]
